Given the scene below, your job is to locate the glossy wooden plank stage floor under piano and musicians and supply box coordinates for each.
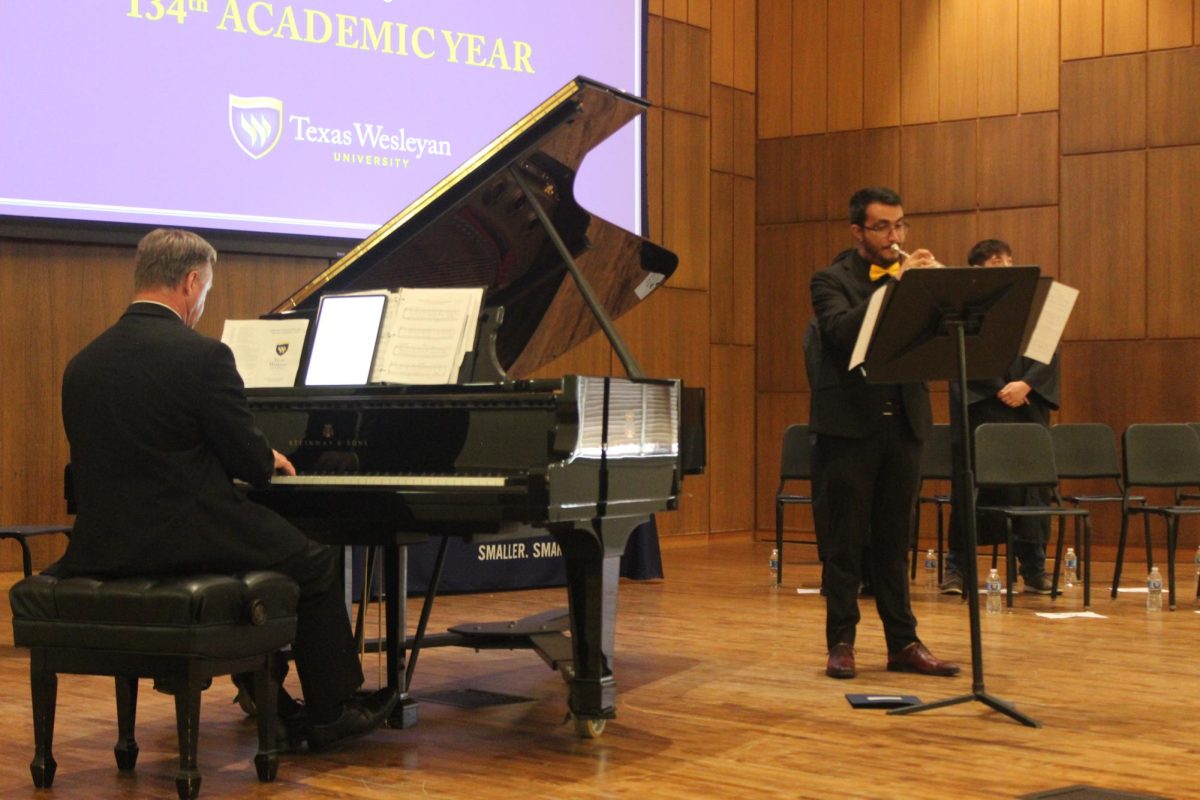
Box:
[0,539,1200,799]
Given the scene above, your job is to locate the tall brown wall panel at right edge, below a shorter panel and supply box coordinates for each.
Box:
[1146,146,1200,338]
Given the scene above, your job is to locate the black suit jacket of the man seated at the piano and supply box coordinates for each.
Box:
[48,302,306,575]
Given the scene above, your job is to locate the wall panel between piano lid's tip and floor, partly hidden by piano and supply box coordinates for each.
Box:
[617,285,718,535]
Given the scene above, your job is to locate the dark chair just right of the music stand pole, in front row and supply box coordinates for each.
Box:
[968,422,1094,608]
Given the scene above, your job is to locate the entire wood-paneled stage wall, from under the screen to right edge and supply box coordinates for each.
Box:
[0,0,1200,570]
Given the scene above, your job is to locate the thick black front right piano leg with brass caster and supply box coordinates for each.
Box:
[551,518,644,738]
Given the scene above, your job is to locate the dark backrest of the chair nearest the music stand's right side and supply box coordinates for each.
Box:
[976,422,1058,487]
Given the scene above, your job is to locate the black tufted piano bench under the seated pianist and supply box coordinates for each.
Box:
[8,572,300,798]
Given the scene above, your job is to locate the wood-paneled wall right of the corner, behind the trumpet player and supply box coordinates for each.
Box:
[755,0,1200,542]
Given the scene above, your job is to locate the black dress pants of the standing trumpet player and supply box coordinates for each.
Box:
[812,414,920,652]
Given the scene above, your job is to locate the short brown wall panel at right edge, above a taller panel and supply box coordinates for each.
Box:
[1146,47,1200,148]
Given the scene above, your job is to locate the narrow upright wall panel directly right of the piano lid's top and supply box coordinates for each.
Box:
[662,110,709,289]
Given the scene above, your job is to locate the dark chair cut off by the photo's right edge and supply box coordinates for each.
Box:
[1112,423,1200,610]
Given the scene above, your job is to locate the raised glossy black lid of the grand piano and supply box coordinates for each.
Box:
[270,77,678,378]
